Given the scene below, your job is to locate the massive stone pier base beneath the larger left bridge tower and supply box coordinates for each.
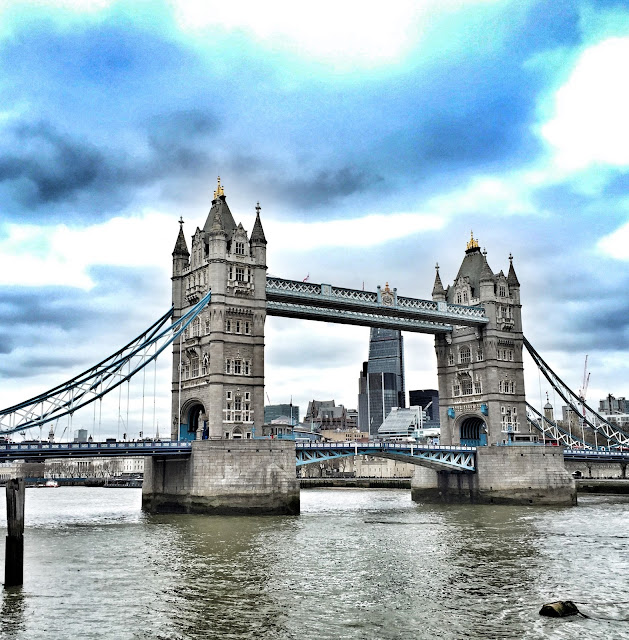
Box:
[142,440,299,515]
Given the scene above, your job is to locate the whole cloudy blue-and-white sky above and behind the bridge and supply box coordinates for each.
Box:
[0,0,629,435]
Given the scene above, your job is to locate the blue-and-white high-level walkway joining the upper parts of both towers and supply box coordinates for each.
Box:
[266,277,489,333]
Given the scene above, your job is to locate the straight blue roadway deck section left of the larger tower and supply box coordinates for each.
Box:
[0,440,192,462]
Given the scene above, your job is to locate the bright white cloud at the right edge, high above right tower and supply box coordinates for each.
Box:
[541,38,629,170]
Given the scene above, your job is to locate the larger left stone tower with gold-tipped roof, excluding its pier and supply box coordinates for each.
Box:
[171,177,266,440]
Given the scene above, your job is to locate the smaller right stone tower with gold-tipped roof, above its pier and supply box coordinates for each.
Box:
[432,235,535,446]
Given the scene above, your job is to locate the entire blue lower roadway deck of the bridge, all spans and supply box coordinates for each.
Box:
[0,437,629,473]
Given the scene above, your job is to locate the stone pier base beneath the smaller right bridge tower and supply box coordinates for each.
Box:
[411,445,577,505]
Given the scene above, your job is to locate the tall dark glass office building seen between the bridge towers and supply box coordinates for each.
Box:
[358,328,406,438]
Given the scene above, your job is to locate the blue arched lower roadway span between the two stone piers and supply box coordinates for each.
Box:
[295,442,476,473]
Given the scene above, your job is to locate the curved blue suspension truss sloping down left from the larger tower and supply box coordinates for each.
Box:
[0,292,211,435]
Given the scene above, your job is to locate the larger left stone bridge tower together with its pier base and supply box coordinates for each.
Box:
[142,178,299,514]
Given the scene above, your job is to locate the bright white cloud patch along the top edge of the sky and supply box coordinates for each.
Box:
[172,0,493,67]
